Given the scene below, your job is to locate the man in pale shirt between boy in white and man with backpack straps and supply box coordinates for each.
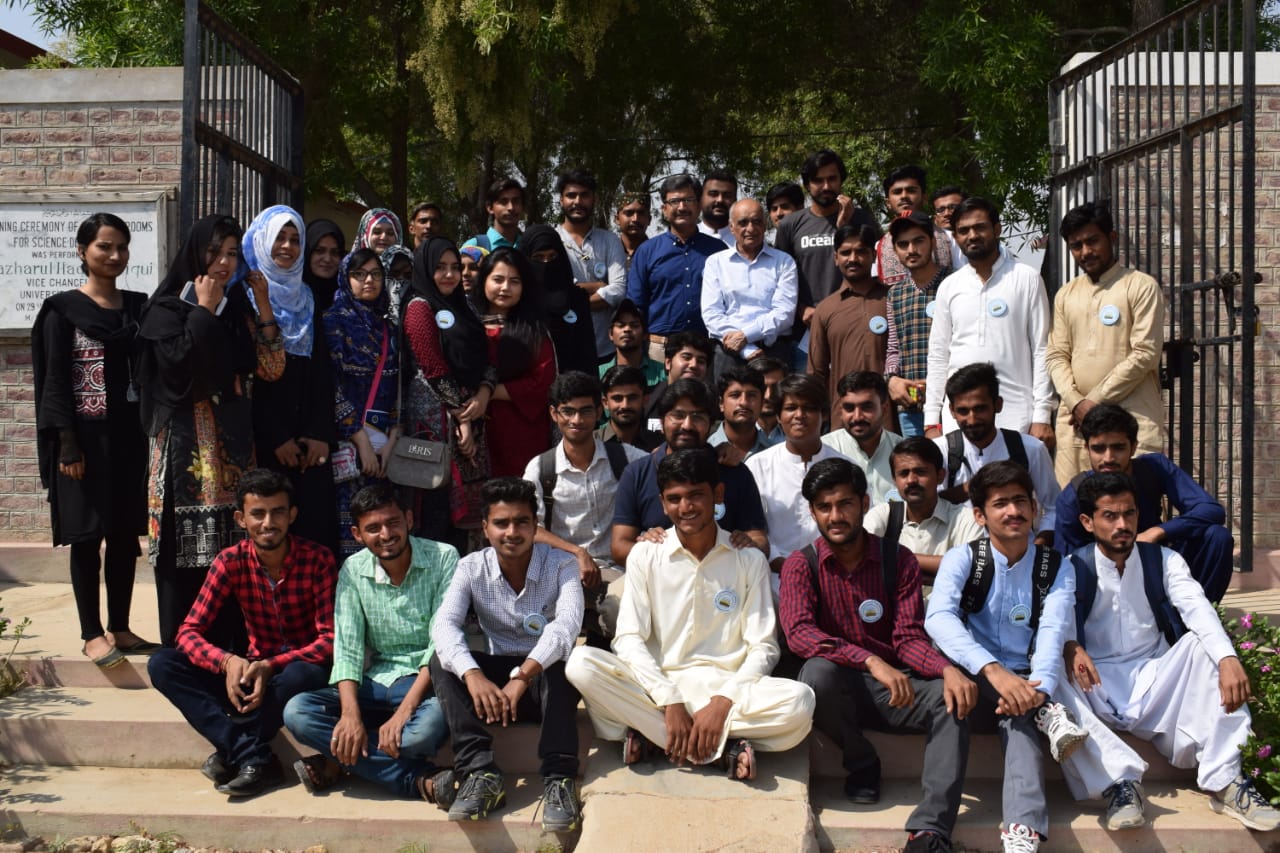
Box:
[822,370,902,506]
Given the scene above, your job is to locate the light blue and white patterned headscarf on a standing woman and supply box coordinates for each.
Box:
[244,205,316,357]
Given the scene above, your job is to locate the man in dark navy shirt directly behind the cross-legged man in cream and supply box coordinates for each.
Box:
[611,379,769,566]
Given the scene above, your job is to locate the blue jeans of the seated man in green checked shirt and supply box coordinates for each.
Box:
[284,675,449,799]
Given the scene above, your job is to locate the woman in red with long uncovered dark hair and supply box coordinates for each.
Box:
[475,248,556,476]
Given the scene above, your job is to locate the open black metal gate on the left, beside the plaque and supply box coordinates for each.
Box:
[179,0,302,234]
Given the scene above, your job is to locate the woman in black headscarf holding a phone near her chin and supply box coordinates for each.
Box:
[137,215,284,648]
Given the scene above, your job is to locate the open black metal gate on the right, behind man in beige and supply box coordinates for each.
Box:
[1048,0,1257,571]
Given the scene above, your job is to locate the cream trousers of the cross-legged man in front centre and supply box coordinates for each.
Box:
[564,646,814,761]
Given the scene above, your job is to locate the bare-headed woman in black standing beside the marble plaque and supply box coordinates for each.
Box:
[31,213,159,669]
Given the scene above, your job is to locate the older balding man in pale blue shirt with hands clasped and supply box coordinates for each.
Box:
[701,199,796,378]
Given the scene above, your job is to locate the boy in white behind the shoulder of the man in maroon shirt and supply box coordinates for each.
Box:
[746,373,844,568]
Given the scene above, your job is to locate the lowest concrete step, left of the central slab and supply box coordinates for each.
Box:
[0,766,573,853]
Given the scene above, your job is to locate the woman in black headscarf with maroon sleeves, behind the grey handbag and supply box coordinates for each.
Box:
[403,237,495,551]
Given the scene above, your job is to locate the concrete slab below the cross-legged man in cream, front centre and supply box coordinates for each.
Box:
[579,740,818,853]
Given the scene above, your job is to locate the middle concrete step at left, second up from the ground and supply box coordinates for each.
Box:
[0,681,593,775]
